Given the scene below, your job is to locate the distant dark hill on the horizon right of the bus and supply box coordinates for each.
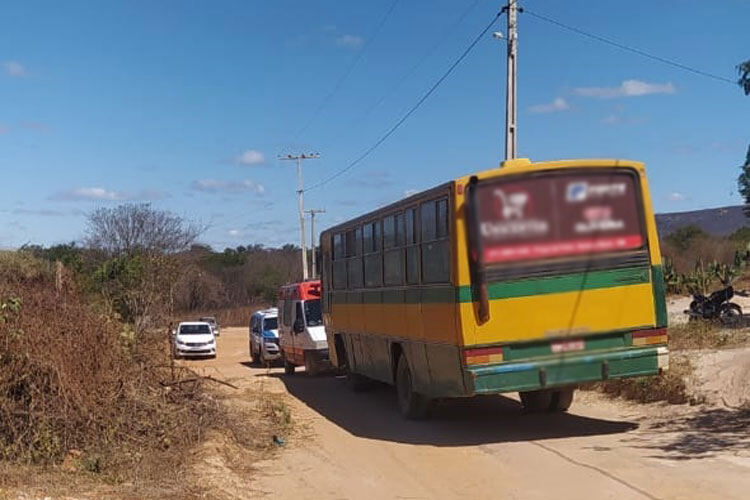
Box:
[656,205,750,237]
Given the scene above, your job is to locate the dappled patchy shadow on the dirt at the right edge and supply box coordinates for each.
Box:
[638,408,750,460]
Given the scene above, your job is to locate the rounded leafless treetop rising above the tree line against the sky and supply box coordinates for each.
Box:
[86,203,204,255]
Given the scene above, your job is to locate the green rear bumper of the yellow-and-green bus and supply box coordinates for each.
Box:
[465,346,669,394]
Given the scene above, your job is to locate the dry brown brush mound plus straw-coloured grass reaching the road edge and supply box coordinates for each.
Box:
[0,253,291,498]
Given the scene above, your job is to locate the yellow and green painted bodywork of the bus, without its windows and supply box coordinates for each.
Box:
[321,160,668,397]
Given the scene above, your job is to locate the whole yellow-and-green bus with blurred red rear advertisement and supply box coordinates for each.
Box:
[321,159,669,418]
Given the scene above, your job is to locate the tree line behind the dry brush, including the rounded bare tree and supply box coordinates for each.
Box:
[21,204,302,335]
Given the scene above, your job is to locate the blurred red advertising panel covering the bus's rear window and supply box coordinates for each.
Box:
[477,171,645,264]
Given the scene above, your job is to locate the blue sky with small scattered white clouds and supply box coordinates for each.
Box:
[0,0,750,249]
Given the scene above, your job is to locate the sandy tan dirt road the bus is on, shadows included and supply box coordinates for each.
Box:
[184,328,750,499]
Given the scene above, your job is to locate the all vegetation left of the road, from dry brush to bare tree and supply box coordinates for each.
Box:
[0,205,295,496]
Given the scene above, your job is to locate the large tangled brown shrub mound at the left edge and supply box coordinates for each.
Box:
[0,254,219,474]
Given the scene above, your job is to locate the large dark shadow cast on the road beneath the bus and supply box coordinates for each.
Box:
[247,372,638,446]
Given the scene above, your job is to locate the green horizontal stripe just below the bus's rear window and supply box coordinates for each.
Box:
[458,267,649,302]
